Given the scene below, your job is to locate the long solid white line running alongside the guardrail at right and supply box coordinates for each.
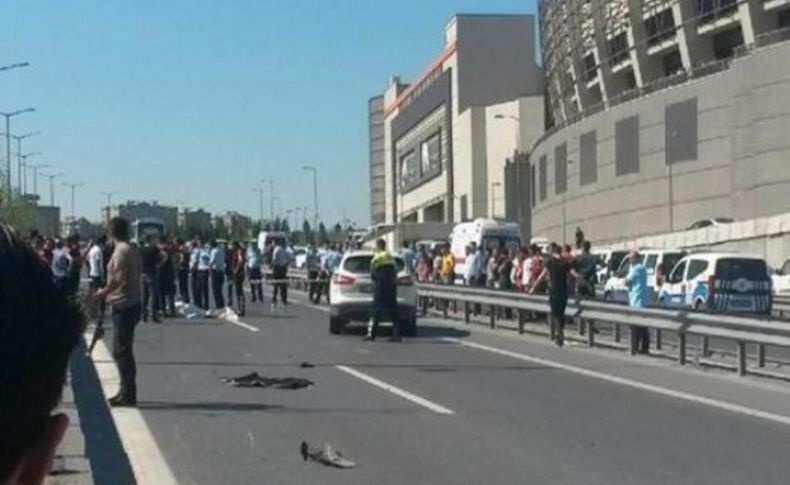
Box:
[443,337,790,426]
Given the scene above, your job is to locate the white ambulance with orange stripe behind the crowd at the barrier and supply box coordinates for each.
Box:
[450,219,521,276]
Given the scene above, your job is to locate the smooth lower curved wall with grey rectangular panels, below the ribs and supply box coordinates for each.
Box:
[531,37,790,243]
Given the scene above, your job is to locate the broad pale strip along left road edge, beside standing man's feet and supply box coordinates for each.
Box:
[84,334,178,485]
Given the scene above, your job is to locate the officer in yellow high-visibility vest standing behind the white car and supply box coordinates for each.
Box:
[365,239,400,342]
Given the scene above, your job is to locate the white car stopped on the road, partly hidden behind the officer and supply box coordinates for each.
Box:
[329,251,417,337]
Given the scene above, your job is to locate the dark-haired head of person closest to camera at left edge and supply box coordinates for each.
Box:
[0,223,85,485]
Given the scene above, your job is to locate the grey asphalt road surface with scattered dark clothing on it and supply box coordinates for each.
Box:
[86,294,790,485]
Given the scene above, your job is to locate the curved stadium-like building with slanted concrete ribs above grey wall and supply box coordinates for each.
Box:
[530,0,790,243]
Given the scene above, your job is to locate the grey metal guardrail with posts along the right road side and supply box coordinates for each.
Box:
[417,283,790,375]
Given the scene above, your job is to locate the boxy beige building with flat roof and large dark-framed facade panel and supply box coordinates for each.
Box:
[378,15,544,224]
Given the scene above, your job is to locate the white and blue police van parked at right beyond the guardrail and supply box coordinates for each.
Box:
[658,253,773,314]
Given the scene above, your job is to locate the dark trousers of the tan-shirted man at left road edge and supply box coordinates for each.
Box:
[112,303,142,400]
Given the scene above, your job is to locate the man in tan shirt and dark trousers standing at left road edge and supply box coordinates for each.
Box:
[96,217,143,407]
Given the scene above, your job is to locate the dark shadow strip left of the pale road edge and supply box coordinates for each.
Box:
[69,342,135,485]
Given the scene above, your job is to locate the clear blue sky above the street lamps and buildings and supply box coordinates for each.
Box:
[0,0,535,225]
